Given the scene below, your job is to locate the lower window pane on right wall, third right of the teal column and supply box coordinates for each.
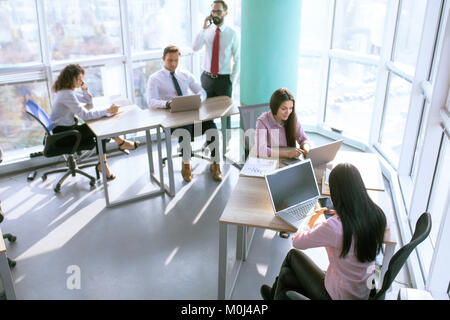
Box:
[379,74,411,167]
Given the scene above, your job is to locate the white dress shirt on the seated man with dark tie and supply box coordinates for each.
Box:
[147,67,206,108]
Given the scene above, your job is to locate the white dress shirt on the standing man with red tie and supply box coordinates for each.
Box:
[192,24,240,83]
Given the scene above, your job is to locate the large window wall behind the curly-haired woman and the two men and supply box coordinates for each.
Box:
[0,0,246,160]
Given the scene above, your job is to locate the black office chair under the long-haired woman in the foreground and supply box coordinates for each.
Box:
[286,212,431,300]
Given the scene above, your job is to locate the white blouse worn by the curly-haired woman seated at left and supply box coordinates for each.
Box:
[49,89,107,130]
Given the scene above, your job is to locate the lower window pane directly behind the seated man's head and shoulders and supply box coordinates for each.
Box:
[133,56,191,109]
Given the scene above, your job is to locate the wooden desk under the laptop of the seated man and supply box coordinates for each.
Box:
[148,96,239,196]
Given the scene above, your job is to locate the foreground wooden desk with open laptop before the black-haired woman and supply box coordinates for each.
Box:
[218,152,396,300]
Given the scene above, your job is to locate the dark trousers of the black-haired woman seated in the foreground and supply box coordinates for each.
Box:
[272,249,331,300]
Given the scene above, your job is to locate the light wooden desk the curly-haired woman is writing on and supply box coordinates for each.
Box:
[86,105,164,207]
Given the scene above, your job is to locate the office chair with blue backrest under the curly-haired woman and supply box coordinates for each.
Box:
[25,100,96,192]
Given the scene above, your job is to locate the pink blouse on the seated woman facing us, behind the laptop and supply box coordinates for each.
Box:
[255,111,308,157]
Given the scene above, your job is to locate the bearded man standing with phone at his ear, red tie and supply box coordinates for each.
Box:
[193,0,240,179]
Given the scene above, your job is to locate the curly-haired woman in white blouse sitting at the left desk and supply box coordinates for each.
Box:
[49,64,139,180]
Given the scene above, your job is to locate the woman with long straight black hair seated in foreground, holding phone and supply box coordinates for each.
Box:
[261,163,389,300]
